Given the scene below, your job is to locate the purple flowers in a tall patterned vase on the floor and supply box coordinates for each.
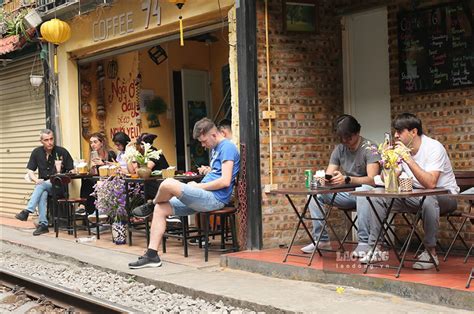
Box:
[92,176,128,245]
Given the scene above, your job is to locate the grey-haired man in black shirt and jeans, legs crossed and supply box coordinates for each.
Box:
[15,129,74,236]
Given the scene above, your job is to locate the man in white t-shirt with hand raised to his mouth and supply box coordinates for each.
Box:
[361,113,459,270]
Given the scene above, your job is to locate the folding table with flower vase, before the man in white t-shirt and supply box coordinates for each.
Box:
[351,188,449,278]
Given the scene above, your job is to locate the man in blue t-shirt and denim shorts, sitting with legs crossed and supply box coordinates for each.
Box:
[128,118,240,269]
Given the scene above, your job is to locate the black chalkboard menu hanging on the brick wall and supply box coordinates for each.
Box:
[398,2,474,94]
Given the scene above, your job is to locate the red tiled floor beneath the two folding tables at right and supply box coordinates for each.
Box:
[229,243,474,292]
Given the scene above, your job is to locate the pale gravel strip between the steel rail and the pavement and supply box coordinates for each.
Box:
[0,243,255,313]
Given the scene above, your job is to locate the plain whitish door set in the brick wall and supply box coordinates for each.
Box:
[342,7,391,143]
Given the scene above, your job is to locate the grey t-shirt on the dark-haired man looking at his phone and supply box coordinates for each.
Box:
[329,137,380,177]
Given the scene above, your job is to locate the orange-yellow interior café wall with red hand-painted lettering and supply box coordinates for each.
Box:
[76,29,229,165]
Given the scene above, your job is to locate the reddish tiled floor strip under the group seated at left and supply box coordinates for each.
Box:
[0,216,220,268]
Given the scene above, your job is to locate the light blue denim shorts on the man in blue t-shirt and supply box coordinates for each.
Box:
[170,184,225,216]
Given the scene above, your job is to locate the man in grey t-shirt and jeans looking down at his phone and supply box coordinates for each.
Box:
[301,115,380,256]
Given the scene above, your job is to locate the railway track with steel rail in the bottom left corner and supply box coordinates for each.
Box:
[0,268,136,313]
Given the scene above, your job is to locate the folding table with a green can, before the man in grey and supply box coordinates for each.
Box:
[269,185,360,266]
